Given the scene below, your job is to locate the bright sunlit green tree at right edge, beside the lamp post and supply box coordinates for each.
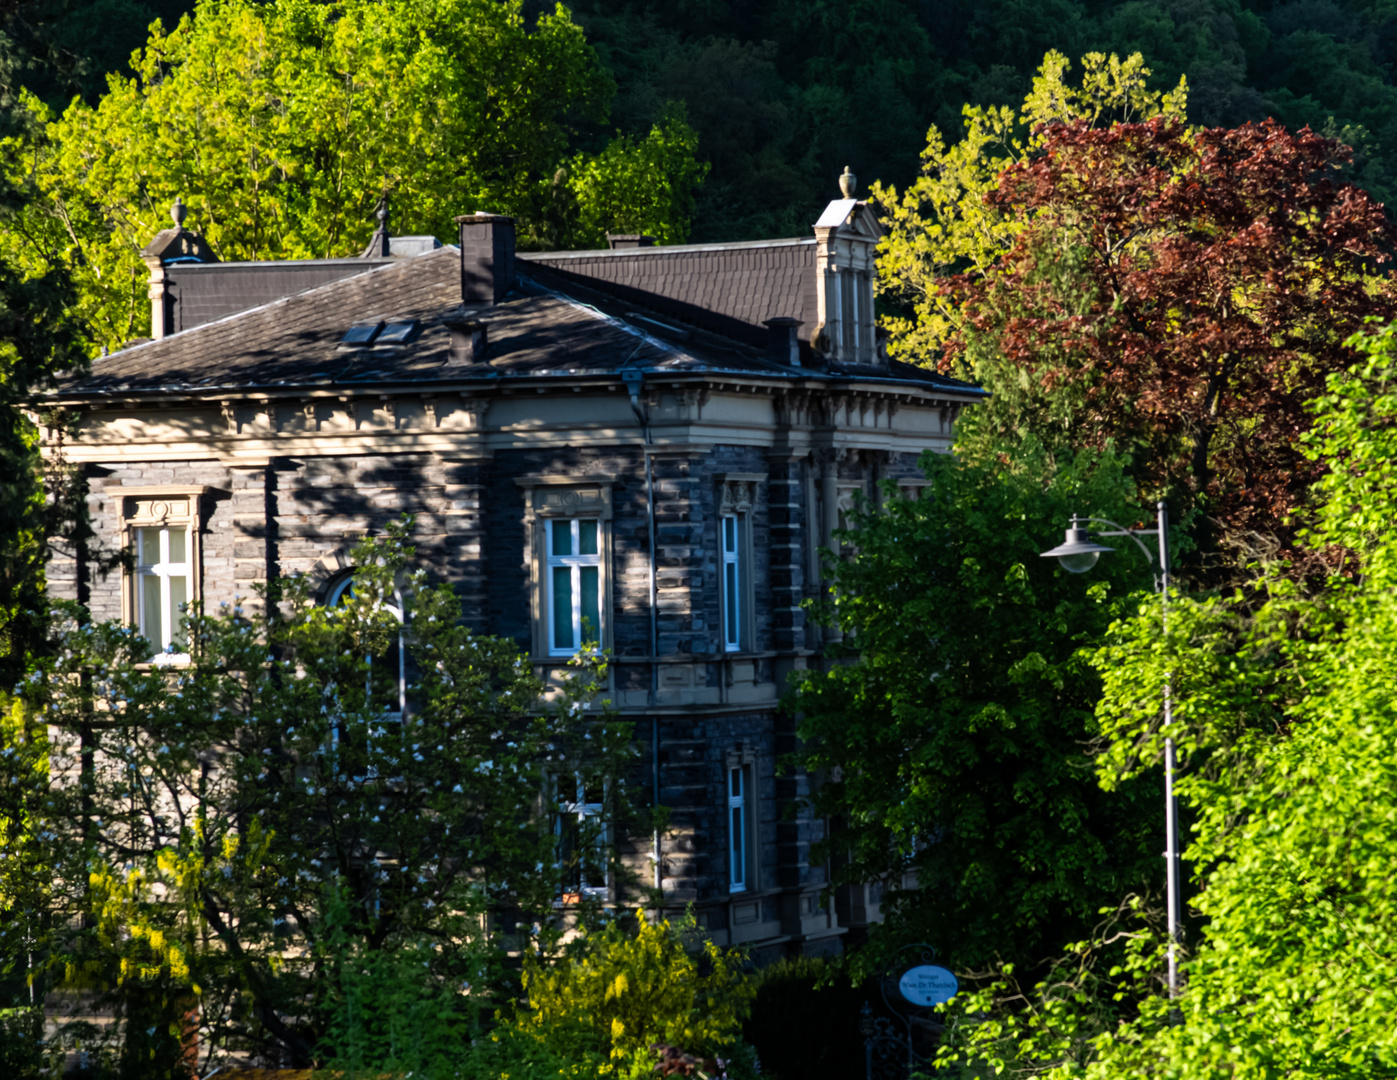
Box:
[933,318,1397,1080]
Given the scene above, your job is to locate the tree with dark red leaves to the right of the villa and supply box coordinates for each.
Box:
[942,117,1397,572]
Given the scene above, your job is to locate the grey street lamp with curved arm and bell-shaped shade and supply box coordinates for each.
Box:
[1042,500,1183,998]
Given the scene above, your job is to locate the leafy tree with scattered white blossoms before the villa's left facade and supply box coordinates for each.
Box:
[0,524,631,1066]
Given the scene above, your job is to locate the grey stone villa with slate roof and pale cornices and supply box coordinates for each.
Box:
[40,178,979,957]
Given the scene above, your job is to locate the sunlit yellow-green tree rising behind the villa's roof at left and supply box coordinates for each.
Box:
[4,0,701,346]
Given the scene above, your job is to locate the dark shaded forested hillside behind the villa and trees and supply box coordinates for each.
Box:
[0,0,1397,240]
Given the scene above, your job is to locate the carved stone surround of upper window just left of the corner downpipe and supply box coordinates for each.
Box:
[514,475,616,664]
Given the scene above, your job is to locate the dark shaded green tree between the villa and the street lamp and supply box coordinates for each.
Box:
[788,442,1161,965]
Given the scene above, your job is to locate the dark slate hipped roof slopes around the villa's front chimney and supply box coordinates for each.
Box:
[52,245,981,400]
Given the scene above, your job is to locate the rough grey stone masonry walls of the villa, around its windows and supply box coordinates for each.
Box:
[62,435,823,950]
